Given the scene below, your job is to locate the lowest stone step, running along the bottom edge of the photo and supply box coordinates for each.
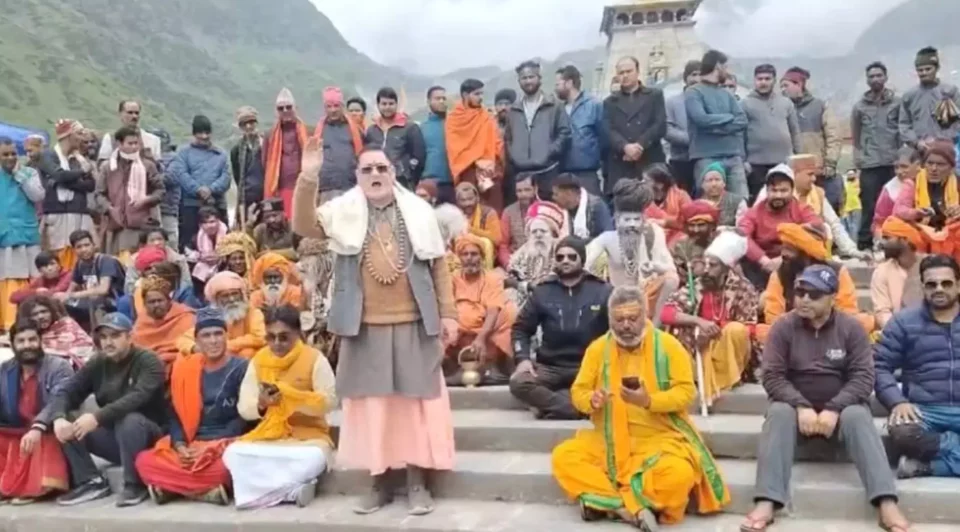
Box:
[0,496,956,532]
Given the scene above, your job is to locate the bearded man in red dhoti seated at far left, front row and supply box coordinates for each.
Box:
[0,321,75,505]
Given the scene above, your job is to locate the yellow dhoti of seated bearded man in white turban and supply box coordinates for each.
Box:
[703,322,750,406]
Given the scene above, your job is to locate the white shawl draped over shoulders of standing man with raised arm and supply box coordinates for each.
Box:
[317,184,447,260]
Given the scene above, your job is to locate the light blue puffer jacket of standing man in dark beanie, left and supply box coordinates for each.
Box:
[167,144,230,208]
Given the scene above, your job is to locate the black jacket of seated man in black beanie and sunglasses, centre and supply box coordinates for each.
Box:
[511,274,613,368]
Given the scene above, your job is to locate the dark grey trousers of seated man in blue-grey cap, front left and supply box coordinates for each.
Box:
[63,412,163,487]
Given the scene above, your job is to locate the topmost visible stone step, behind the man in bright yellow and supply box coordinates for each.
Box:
[450,384,887,416]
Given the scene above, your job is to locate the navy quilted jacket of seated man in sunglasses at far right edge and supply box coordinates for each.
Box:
[875,305,960,409]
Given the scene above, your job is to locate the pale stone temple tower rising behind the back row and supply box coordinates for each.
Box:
[594,0,706,97]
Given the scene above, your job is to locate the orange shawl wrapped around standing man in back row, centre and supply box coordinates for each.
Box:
[444,101,502,184]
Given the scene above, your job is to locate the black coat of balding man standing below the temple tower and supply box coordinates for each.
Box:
[603,87,667,194]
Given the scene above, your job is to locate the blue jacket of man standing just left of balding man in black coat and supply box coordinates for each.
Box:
[562,92,607,172]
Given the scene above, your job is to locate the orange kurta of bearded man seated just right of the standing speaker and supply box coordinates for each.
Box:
[453,271,517,356]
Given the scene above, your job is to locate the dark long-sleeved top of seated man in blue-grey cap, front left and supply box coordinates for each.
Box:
[50,347,166,427]
